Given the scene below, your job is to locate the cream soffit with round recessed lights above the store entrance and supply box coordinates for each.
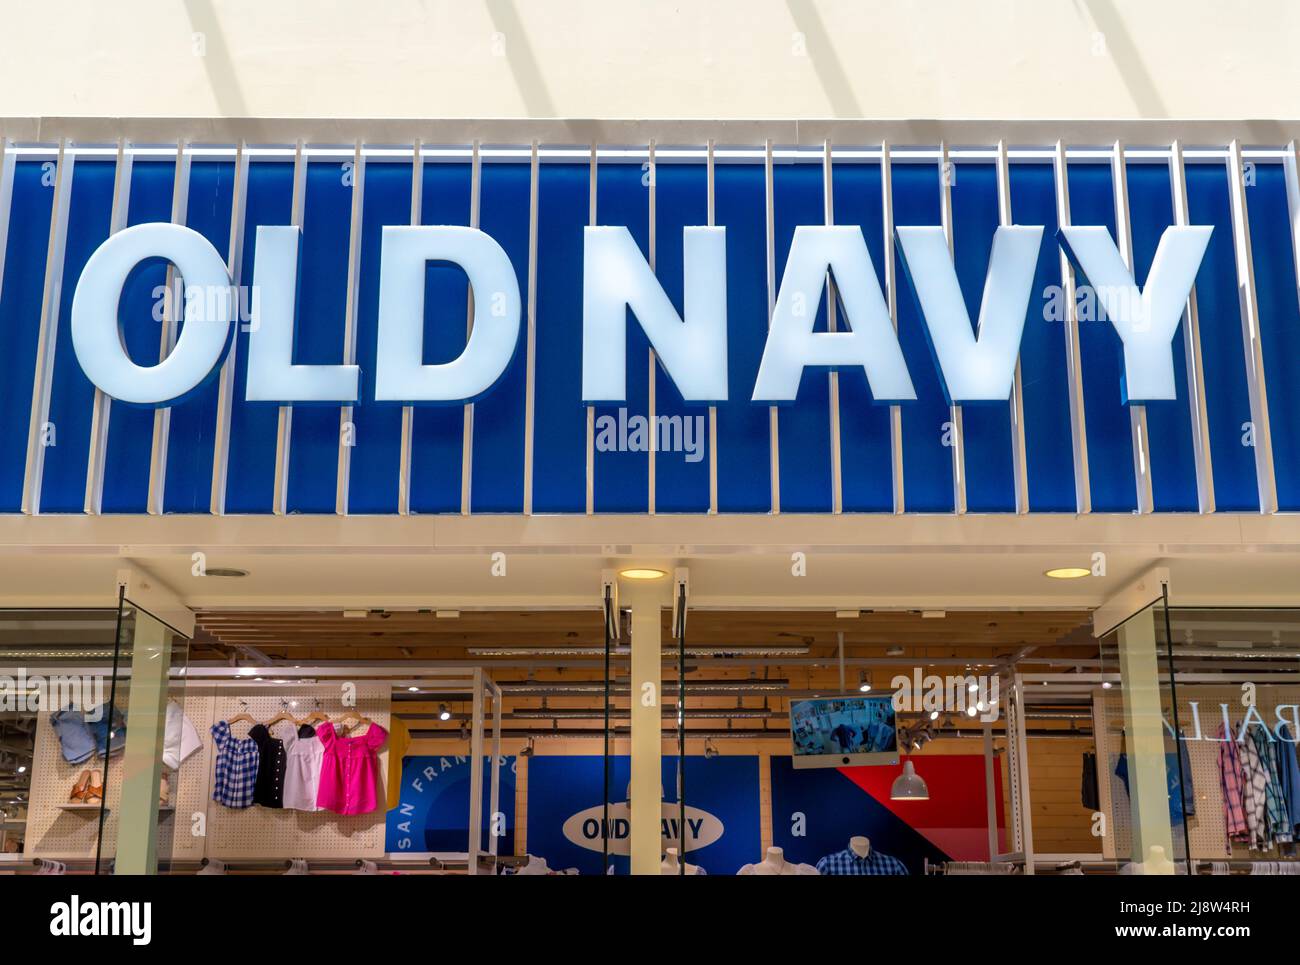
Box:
[0,548,1300,609]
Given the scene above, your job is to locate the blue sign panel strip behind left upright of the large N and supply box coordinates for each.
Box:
[592,163,650,512]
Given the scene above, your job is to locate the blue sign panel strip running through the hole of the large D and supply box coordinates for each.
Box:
[411,163,473,512]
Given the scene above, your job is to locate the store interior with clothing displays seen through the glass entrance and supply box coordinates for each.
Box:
[0,600,1300,875]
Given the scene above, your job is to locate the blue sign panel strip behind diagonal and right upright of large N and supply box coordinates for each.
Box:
[653,164,709,512]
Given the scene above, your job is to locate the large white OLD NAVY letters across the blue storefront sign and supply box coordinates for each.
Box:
[72,222,1212,406]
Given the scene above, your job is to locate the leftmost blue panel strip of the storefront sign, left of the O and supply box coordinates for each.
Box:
[0,161,55,512]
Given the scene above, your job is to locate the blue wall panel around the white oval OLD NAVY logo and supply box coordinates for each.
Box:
[528,756,762,874]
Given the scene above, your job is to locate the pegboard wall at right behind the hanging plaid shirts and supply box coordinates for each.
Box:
[1096,685,1300,861]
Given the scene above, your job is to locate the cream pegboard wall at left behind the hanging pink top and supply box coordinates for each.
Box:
[27,681,390,861]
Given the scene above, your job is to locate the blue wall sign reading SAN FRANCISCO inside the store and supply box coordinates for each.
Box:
[384,754,516,854]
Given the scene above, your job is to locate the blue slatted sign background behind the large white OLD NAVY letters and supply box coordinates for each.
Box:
[0,157,1300,514]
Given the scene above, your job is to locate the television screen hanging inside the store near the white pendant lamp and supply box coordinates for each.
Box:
[790,697,898,767]
